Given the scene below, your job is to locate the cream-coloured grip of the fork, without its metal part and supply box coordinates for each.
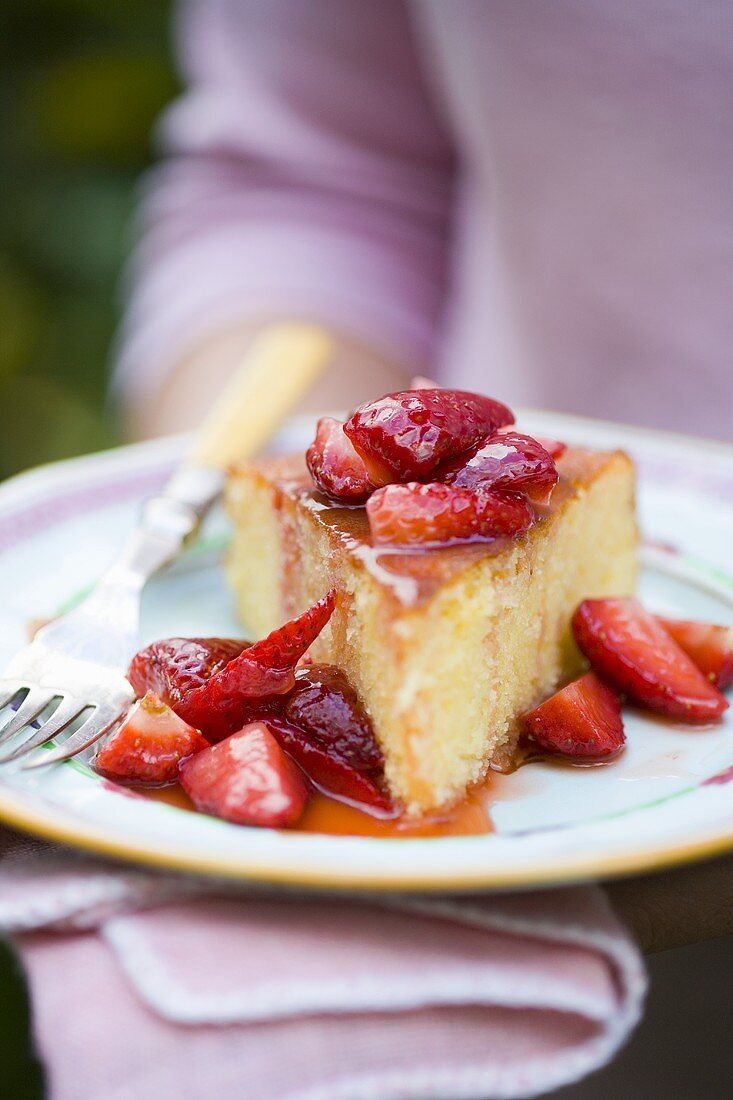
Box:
[187,321,333,470]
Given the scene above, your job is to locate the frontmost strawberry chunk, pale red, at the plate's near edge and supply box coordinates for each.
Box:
[178,722,308,828]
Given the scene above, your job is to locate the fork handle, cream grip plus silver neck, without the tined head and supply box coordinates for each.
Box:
[100,321,333,587]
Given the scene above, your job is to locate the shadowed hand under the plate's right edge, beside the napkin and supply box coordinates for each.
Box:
[606,856,733,954]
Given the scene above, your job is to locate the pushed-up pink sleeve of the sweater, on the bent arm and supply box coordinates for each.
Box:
[117,0,452,399]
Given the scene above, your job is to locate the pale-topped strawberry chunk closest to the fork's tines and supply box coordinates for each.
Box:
[95,691,209,784]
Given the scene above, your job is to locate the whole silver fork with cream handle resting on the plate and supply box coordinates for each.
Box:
[0,322,332,770]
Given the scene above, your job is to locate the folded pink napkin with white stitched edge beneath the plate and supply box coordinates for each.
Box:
[0,833,646,1100]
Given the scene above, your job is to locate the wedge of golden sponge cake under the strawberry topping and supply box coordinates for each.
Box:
[227,449,638,814]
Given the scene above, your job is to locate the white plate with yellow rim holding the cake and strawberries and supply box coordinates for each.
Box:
[0,411,733,891]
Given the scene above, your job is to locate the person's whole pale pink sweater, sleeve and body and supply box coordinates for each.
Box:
[118,0,733,438]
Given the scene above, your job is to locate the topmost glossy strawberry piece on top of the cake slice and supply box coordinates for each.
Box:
[343,389,514,485]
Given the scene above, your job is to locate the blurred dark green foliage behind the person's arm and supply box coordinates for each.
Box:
[0,0,176,477]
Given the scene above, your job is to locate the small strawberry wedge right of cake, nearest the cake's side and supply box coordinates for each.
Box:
[523,672,626,760]
